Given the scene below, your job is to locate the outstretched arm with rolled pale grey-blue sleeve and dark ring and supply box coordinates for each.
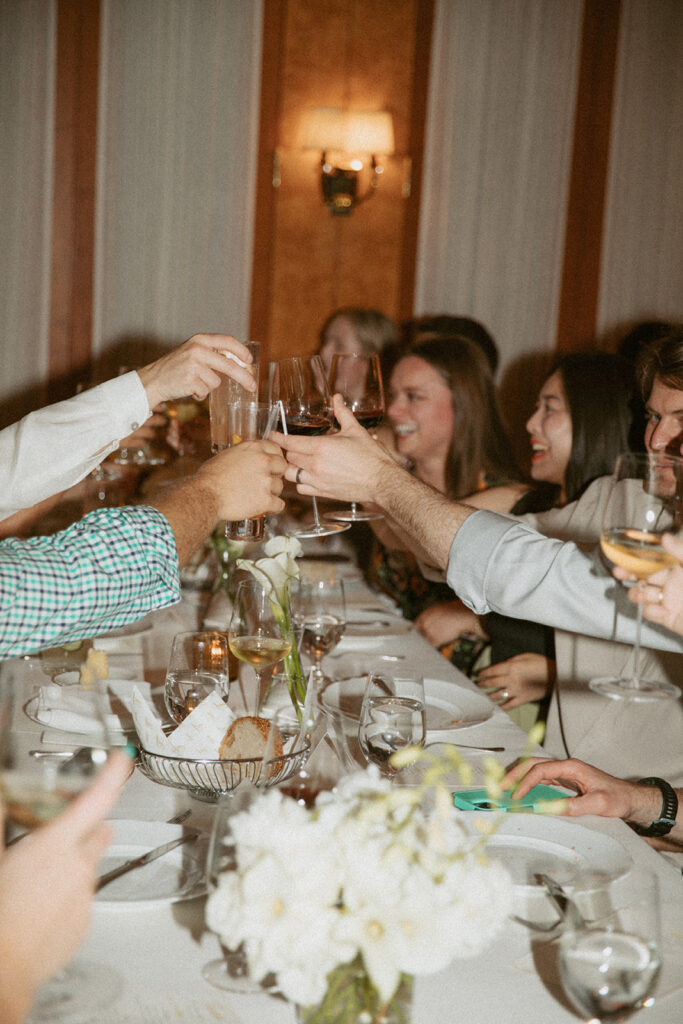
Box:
[274,396,683,652]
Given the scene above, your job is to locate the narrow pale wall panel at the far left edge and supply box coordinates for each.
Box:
[0,0,55,411]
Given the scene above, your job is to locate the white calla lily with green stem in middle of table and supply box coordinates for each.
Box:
[237,537,306,717]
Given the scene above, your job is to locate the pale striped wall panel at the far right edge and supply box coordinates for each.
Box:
[598,0,683,331]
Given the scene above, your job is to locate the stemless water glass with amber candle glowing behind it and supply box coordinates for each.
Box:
[164,631,228,724]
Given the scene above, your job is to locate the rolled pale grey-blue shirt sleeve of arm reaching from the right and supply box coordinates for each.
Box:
[447,511,683,653]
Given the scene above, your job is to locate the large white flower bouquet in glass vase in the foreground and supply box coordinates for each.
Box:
[207,748,512,1024]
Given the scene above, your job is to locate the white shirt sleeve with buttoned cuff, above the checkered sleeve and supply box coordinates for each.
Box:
[0,371,152,520]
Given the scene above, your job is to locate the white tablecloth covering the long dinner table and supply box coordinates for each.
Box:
[10,580,683,1024]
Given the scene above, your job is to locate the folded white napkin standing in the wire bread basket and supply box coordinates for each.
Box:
[131,687,236,760]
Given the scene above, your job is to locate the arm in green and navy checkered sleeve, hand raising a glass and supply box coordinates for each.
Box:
[0,441,286,657]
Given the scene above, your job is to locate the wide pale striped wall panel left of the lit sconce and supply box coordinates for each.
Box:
[93,0,262,362]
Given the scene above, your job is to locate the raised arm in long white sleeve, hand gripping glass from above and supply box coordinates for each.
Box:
[0,334,255,520]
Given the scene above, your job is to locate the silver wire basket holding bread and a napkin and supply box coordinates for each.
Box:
[137,739,310,802]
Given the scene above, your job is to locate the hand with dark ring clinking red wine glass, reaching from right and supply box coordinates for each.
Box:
[270,394,398,505]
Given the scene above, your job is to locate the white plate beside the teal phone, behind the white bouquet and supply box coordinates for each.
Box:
[461,811,631,888]
